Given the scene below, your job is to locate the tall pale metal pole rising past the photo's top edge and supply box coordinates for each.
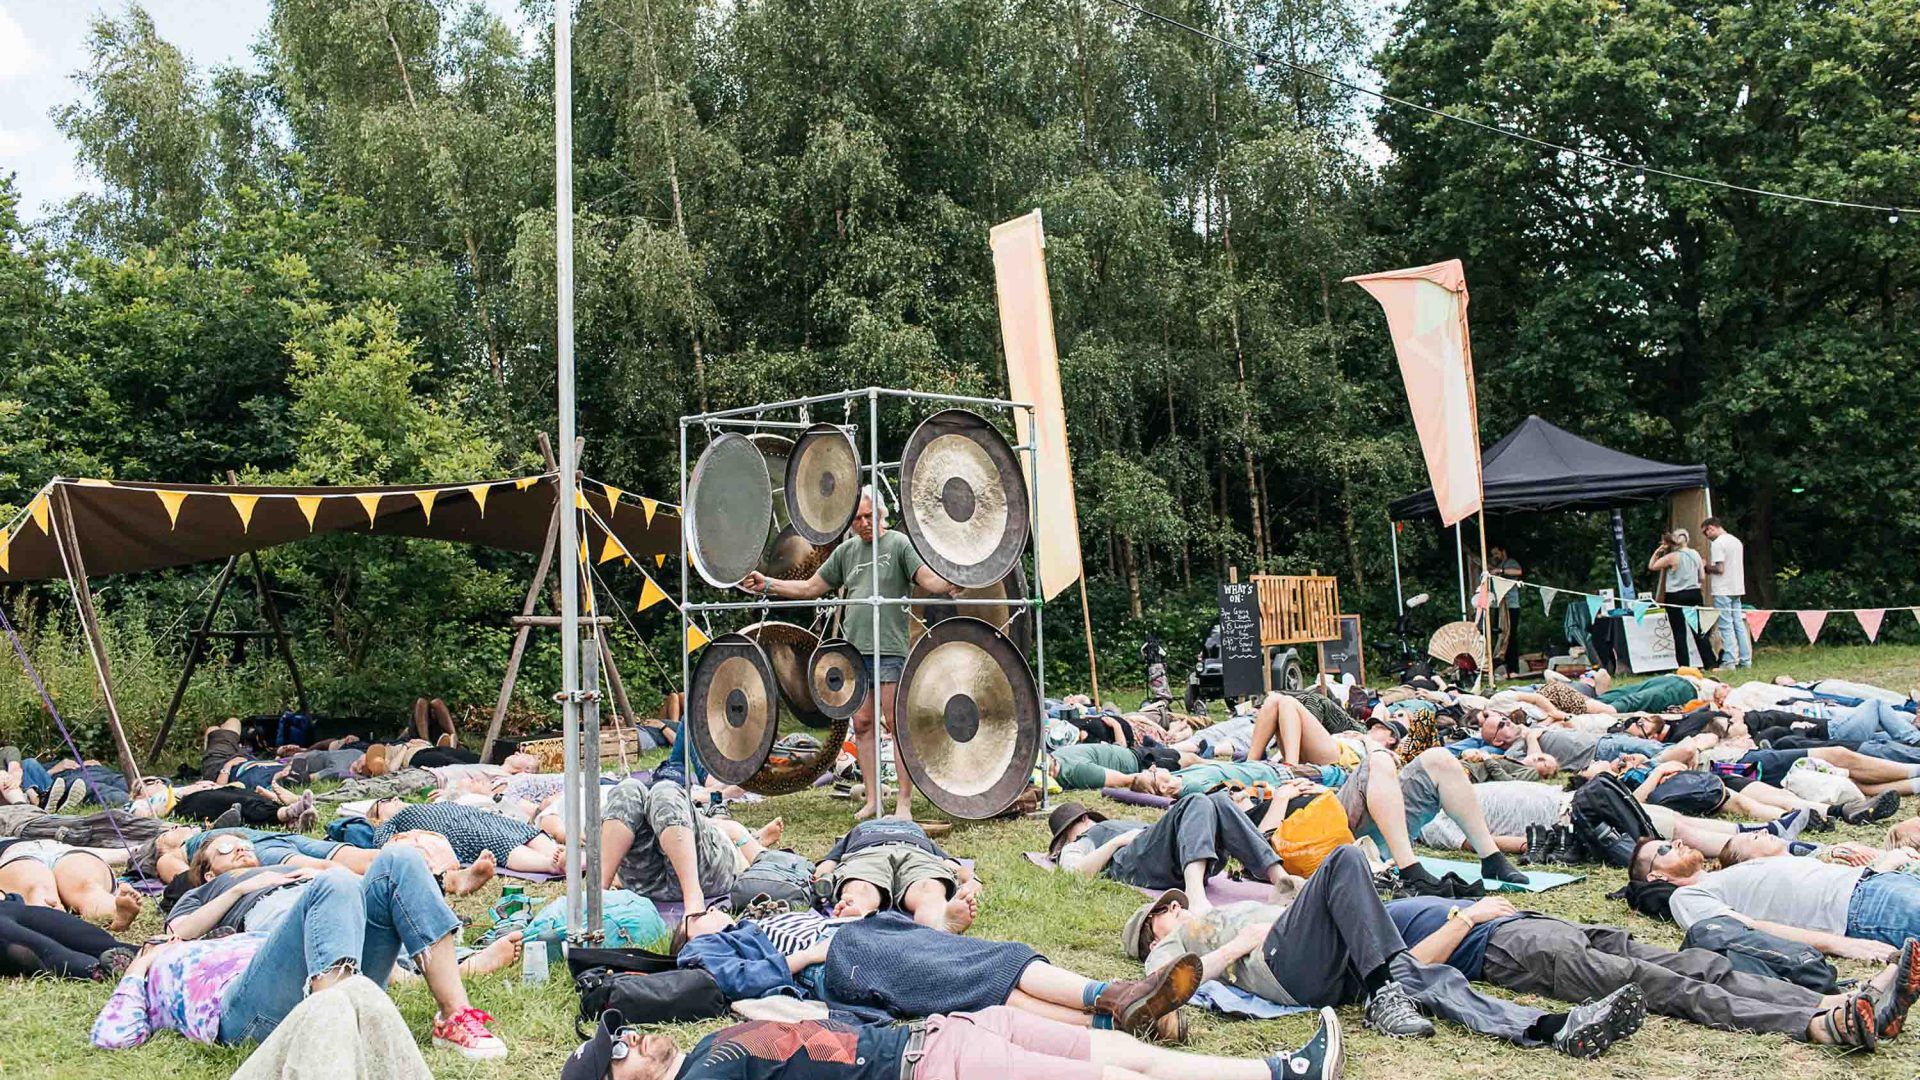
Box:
[553,0,579,940]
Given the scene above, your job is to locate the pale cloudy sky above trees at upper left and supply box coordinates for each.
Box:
[0,0,522,221]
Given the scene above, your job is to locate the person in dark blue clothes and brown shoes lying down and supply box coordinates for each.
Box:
[674,911,1200,1040]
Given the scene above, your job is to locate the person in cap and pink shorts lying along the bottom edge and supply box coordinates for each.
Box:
[561,1005,1346,1080]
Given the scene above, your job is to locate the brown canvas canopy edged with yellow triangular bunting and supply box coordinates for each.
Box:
[0,473,680,778]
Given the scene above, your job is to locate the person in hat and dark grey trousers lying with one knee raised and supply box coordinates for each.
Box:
[1121,844,1645,1057]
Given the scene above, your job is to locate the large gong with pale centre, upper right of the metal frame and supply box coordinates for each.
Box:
[900,409,1029,588]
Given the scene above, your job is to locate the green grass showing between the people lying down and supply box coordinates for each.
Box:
[0,646,1920,1080]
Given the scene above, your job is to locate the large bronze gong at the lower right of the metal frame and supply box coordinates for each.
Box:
[893,617,1041,821]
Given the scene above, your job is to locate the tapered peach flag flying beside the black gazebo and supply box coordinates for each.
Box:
[1344,259,1480,525]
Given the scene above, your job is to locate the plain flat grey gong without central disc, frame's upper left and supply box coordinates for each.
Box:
[685,432,774,588]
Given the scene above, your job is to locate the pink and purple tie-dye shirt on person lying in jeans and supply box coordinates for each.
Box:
[92,934,267,1049]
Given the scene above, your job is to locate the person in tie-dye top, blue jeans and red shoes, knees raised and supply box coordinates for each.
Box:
[92,847,507,1061]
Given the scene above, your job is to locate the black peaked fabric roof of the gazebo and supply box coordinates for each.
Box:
[1388,417,1707,521]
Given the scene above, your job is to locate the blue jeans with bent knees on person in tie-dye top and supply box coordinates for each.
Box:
[221,847,461,1045]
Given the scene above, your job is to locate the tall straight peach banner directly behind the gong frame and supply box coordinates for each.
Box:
[989,209,1081,600]
